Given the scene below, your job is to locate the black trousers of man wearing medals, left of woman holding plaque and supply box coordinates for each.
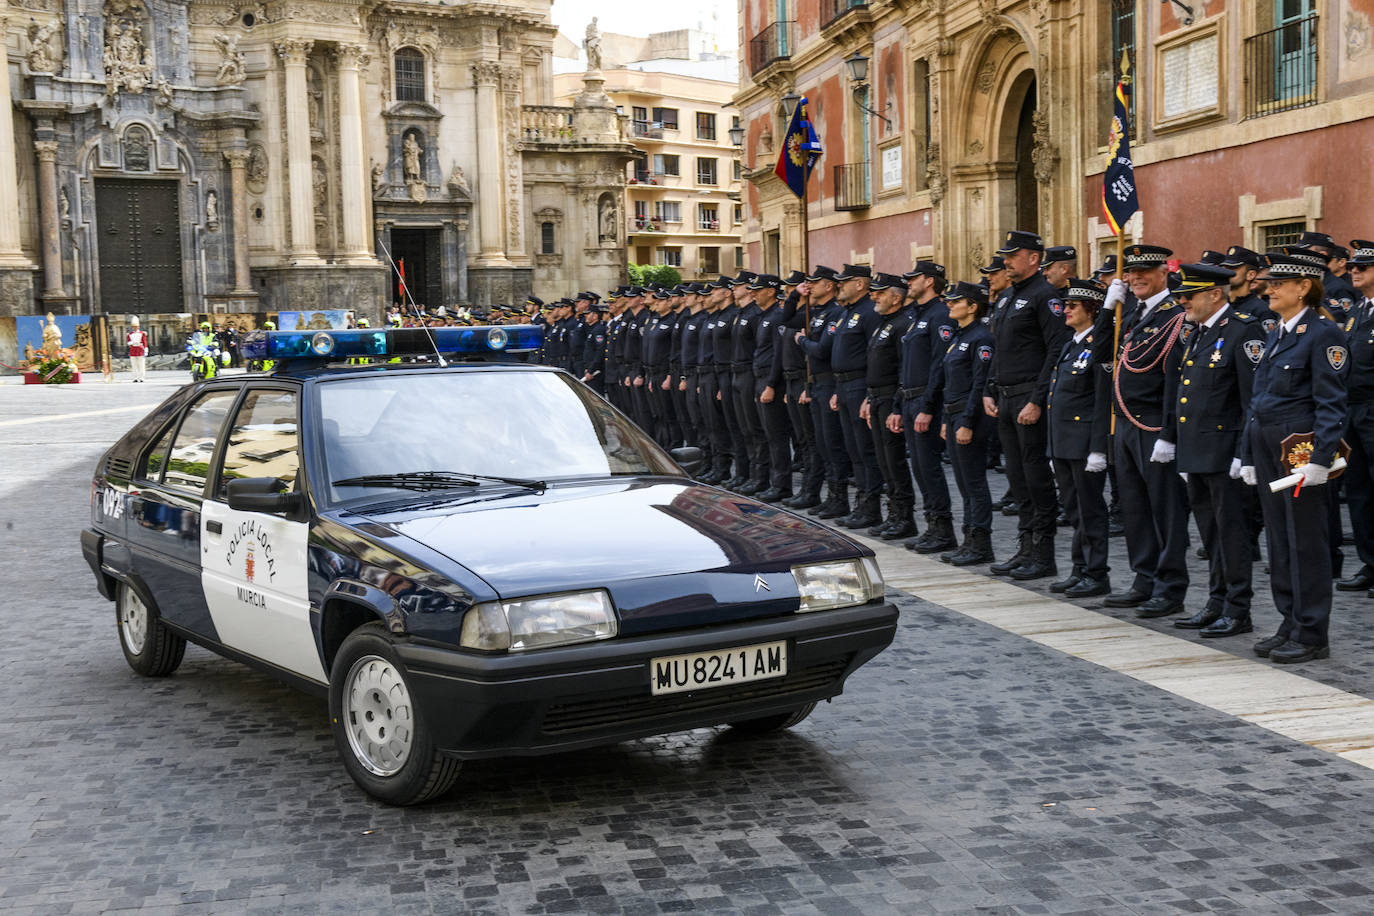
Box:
[1187,468,1254,618]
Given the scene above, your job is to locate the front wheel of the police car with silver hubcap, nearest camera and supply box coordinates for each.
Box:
[330,623,463,805]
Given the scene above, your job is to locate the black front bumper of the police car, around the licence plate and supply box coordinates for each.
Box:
[396,603,897,758]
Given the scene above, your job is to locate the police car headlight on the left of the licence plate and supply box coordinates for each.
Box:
[462,589,618,651]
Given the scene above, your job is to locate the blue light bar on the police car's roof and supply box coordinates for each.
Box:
[239,324,544,361]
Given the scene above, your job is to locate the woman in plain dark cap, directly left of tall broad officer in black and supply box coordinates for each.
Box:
[926,283,996,566]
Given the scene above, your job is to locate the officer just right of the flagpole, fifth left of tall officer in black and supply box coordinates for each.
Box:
[793,264,853,519]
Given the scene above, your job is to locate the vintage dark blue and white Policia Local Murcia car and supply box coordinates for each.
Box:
[81,327,897,805]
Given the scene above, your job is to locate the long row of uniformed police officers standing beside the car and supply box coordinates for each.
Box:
[530,231,1374,662]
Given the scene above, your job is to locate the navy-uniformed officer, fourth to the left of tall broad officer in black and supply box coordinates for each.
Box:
[830,264,882,529]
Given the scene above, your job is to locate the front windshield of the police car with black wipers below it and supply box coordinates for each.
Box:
[315,371,680,501]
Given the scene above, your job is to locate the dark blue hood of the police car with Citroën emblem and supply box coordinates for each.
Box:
[346,478,868,634]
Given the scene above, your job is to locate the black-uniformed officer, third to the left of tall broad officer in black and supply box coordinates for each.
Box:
[860,273,916,541]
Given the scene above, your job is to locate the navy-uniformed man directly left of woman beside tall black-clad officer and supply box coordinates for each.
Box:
[888,261,956,553]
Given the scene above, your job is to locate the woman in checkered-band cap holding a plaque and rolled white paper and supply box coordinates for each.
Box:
[1239,251,1348,665]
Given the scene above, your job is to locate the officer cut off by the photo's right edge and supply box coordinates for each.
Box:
[1336,239,1374,597]
